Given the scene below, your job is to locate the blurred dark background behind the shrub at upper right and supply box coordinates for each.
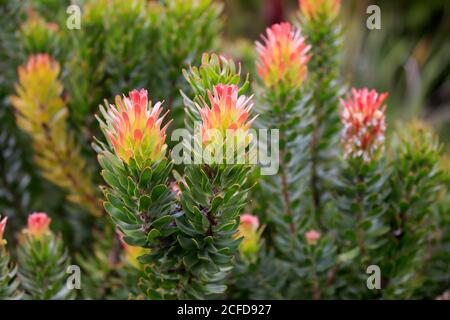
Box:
[222,0,450,153]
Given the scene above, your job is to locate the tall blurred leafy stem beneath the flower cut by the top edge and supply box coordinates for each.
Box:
[300,11,343,229]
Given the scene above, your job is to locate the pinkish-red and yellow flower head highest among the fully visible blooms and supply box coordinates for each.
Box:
[256,22,311,89]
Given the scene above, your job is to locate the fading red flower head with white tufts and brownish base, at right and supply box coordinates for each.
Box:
[340,88,388,162]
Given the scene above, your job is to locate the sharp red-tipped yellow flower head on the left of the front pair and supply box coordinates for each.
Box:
[99,89,171,164]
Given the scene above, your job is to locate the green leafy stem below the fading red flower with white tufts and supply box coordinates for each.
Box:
[336,157,390,298]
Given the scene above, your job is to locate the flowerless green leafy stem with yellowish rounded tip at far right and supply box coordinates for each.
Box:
[384,123,448,298]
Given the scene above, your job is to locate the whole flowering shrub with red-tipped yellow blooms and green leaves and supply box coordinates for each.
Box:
[0,0,450,299]
